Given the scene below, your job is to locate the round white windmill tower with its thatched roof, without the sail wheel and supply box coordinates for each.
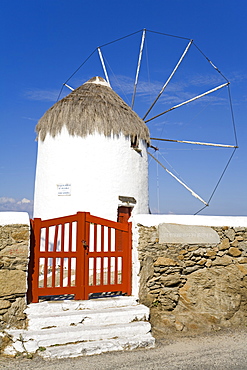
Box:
[34,77,150,221]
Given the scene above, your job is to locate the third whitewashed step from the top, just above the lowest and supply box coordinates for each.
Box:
[8,321,151,352]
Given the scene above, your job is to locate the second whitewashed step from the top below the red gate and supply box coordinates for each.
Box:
[28,305,149,330]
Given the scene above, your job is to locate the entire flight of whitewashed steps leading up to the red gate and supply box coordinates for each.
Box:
[5,297,155,358]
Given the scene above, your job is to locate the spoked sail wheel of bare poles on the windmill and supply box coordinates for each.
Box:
[55,29,238,213]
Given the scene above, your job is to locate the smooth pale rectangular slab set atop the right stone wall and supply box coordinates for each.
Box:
[159,224,220,244]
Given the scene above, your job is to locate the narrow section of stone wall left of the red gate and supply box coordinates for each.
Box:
[0,220,30,330]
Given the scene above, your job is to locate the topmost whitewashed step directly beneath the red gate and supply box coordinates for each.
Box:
[25,296,138,316]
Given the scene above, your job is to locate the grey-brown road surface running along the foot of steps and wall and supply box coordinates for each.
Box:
[0,328,247,370]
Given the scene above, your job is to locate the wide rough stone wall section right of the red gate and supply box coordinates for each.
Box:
[138,225,247,335]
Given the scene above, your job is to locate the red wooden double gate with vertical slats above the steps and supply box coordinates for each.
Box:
[28,212,131,302]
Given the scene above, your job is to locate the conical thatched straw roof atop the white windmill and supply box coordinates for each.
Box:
[36,77,150,143]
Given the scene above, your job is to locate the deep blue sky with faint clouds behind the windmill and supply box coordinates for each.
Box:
[0,0,247,216]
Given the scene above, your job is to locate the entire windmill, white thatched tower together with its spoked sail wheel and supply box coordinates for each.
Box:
[34,29,238,220]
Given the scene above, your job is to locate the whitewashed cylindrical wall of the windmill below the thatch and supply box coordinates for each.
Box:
[34,128,149,221]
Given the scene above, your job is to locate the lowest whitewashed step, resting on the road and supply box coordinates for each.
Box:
[39,333,155,358]
